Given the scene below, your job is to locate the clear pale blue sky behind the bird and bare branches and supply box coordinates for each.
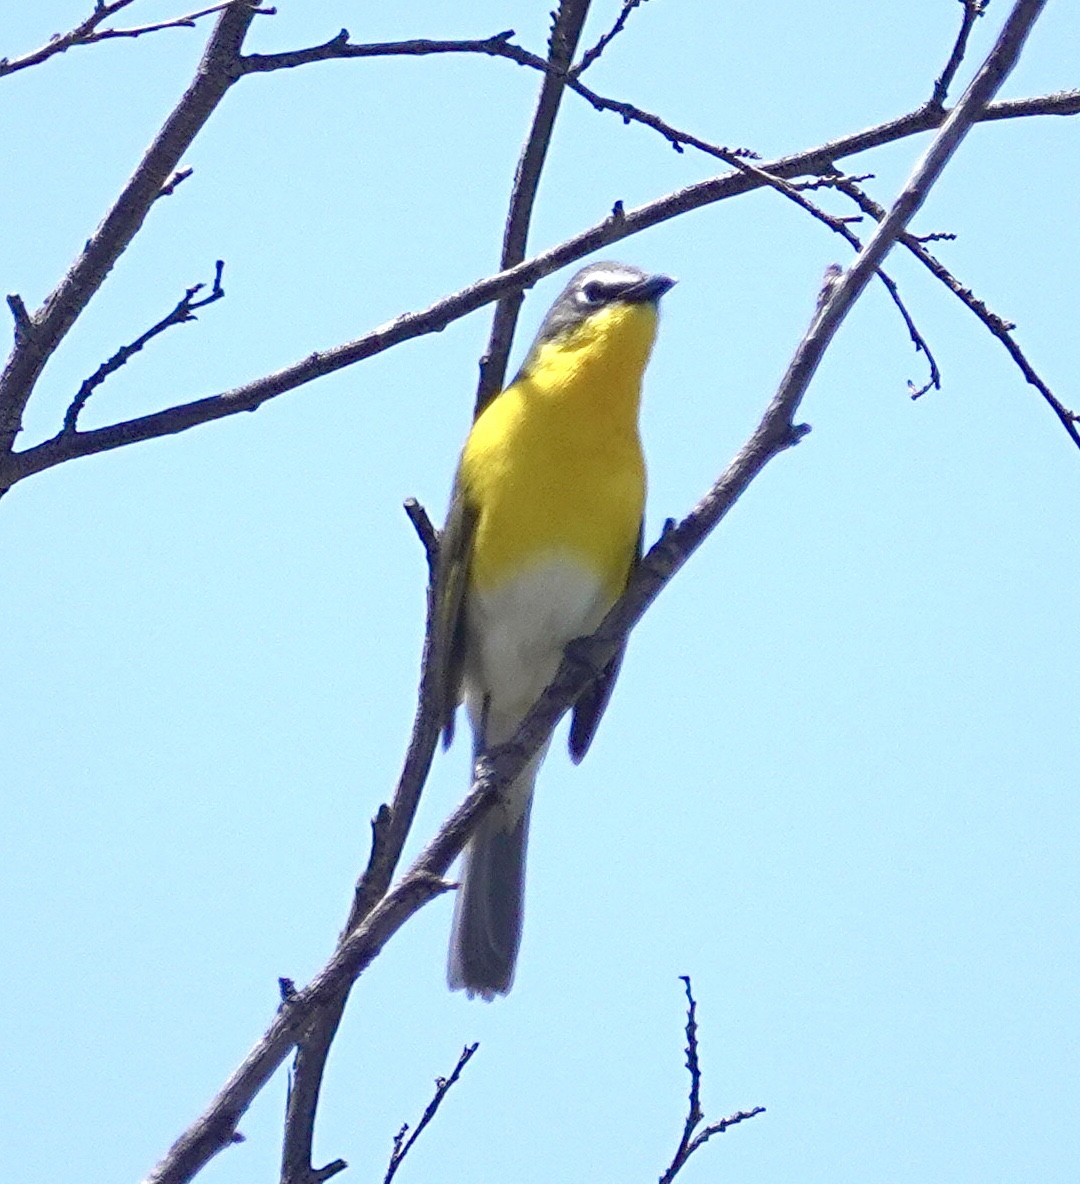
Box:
[0,0,1080,1184]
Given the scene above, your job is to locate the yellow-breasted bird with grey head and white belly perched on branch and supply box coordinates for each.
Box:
[431,263,675,1000]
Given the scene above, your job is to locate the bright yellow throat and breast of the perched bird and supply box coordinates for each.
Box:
[458,304,656,600]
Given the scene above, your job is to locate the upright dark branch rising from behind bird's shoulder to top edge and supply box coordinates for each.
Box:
[473,0,589,418]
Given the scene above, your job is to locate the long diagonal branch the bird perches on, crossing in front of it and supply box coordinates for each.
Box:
[139,13,1046,1184]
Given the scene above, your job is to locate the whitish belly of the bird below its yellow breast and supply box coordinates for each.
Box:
[465,552,610,744]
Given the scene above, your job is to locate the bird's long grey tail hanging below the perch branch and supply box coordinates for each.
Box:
[446,753,541,999]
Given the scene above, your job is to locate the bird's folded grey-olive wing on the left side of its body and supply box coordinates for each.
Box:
[430,483,476,747]
